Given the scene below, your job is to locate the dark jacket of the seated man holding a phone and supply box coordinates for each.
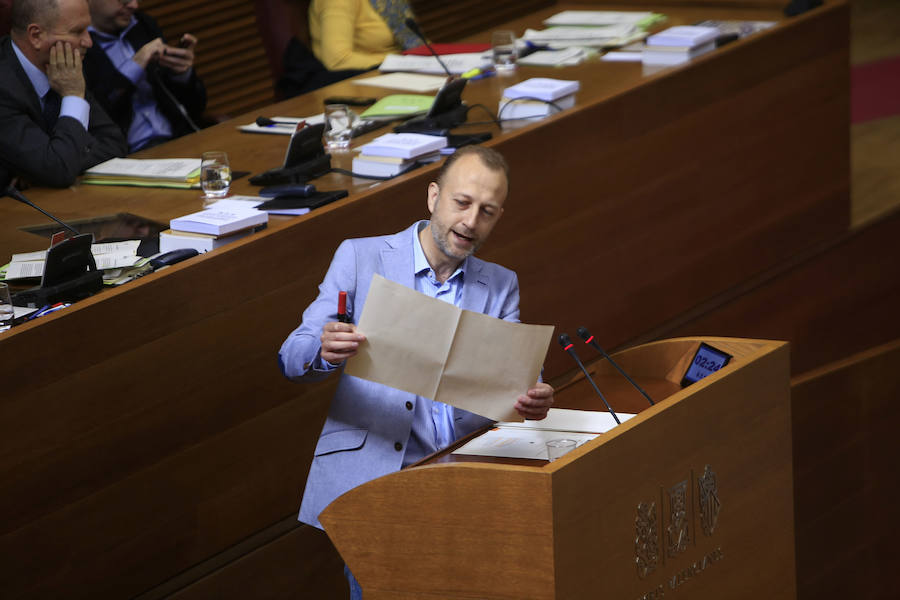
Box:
[84,12,206,144]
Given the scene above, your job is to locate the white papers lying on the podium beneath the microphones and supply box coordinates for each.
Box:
[453,408,634,460]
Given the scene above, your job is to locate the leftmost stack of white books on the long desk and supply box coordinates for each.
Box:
[159,200,269,252]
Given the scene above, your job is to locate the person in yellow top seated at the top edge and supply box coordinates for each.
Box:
[309,0,421,71]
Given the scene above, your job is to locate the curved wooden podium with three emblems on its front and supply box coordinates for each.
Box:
[320,338,796,600]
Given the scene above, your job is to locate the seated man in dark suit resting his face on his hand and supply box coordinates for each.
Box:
[0,0,128,189]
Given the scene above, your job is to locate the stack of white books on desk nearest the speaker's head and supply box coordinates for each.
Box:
[353,133,447,177]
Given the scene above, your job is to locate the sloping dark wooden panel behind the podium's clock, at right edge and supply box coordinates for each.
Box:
[652,211,900,373]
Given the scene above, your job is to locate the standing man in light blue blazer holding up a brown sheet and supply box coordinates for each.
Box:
[279,146,553,536]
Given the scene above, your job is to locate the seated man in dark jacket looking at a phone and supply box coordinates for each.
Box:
[84,0,206,152]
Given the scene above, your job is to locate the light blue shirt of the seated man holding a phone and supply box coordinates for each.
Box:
[88,17,176,152]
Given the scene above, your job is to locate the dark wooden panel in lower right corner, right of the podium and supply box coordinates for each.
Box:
[791,340,900,600]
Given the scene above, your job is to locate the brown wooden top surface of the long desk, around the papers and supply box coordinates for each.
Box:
[0,5,782,257]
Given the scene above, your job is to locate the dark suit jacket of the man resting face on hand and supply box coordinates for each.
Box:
[0,36,128,189]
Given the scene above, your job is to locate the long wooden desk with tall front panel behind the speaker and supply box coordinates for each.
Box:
[0,2,849,597]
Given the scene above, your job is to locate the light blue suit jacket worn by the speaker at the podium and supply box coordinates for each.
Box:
[279,225,519,529]
